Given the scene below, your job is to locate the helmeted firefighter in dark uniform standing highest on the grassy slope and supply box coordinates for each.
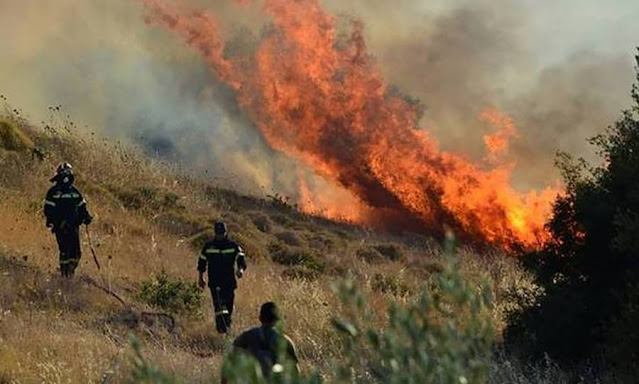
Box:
[44,163,92,277]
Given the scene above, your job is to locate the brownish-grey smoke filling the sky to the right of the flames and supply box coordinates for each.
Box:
[325,0,639,189]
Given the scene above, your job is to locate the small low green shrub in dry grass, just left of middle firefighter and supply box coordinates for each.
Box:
[138,272,202,315]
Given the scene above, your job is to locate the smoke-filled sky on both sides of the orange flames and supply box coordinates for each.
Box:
[0,0,639,193]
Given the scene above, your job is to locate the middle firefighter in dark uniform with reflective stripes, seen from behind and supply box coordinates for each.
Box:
[197,222,246,333]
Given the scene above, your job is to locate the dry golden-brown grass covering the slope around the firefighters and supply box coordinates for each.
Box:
[0,111,540,383]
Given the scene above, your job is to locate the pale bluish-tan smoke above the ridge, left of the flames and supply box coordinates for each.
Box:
[0,0,293,193]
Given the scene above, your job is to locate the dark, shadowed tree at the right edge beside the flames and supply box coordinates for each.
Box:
[507,51,639,372]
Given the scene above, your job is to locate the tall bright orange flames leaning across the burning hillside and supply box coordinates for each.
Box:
[141,0,558,248]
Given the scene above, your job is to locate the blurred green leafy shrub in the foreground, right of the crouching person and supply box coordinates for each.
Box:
[335,256,493,384]
